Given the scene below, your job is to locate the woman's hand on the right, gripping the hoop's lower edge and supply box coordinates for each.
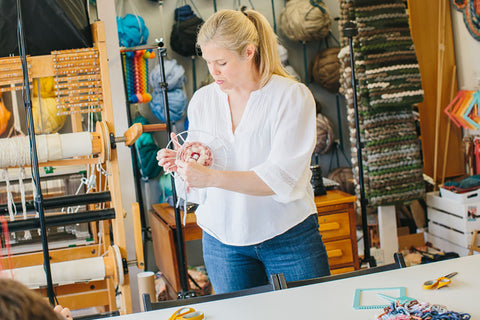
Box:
[176,160,214,192]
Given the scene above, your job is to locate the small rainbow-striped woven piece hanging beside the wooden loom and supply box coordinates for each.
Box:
[122,49,155,103]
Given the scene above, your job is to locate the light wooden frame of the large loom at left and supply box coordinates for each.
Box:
[1,21,135,314]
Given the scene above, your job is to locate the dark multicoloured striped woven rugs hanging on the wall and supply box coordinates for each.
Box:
[339,0,425,206]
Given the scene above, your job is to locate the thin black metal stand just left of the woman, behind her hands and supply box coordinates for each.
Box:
[157,40,195,299]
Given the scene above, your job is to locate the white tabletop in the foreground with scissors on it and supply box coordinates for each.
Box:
[111,255,480,320]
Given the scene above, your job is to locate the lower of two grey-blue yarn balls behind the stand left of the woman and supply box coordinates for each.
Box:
[149,89,187,123]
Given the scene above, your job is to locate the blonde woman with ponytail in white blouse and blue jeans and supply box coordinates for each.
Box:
[157,10,330,293]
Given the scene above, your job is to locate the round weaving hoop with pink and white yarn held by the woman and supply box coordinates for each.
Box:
[167,130,227,170]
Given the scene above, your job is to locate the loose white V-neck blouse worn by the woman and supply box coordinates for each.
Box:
[177,75,316,246]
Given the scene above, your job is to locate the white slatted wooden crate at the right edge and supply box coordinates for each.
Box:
[426,192,480,254]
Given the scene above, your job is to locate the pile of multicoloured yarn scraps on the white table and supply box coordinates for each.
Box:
[377,300,471,320]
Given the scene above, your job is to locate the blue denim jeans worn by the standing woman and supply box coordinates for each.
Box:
[202,214,330,293]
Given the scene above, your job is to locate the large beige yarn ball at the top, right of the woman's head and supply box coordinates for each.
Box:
[279,0,332,42]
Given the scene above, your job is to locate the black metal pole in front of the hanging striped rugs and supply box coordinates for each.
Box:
[343,21,377,267]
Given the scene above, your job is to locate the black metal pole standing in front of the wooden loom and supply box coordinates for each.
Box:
[17,0,55,305]
